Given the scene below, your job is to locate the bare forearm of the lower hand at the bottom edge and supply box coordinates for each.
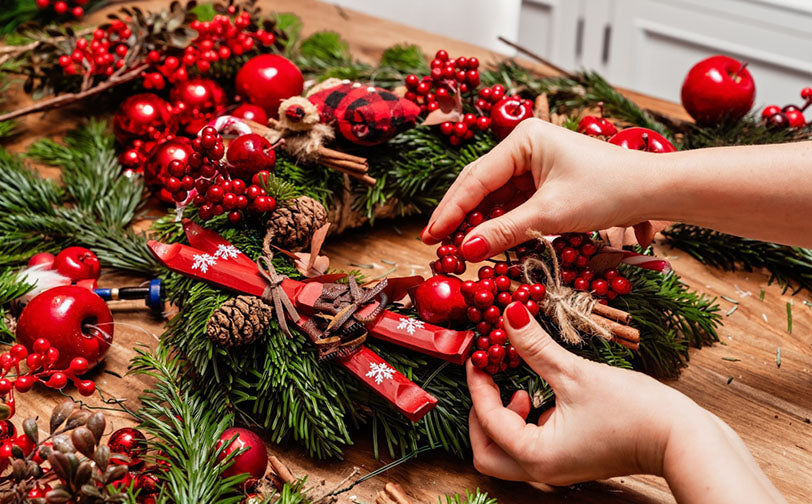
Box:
[663,411,785,504]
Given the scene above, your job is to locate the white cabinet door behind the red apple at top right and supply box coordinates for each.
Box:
[594,0,812,107]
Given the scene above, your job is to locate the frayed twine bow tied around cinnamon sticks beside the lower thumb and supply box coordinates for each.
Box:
[523,230,612,345]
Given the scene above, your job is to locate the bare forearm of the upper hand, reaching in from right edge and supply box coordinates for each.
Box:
[632,142,812,247]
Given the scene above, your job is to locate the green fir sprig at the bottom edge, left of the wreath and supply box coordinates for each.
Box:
[130,344,248,504]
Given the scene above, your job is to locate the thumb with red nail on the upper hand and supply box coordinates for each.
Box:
[460,197,540,262]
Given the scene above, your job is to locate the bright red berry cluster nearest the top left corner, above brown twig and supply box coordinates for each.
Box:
[59,20,132,77]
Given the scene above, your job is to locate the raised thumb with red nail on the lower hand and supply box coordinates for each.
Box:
[505,302,580,393]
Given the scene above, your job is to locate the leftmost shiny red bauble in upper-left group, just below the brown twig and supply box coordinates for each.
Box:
[113,93,178,145]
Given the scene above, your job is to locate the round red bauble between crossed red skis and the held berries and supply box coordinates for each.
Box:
[413,275,468,325]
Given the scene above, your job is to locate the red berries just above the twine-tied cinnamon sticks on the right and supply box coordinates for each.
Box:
[553,233,632,304]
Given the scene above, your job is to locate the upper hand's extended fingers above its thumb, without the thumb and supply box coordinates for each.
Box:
[421,127,532,245]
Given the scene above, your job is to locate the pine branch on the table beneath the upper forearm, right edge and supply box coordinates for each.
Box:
[663,224,812,293]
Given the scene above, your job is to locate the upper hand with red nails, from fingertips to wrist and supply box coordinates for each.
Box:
[422,119,663,262]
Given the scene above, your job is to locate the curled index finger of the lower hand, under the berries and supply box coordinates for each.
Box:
[466,360,538,455]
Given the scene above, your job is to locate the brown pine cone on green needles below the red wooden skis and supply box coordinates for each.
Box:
[206,296,273,347]
